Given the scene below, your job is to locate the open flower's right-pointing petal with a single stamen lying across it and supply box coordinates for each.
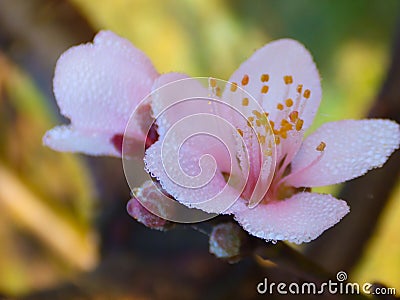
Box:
[287,119,400,187]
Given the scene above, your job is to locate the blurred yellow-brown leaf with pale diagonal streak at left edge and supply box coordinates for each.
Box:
[0,53,97,293]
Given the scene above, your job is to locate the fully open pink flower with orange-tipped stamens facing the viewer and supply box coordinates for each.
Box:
[145,39,400,243]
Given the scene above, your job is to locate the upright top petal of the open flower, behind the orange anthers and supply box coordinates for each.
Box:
[229,39,322,129]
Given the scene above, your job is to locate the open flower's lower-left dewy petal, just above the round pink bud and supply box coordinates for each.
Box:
[145,140,240,213]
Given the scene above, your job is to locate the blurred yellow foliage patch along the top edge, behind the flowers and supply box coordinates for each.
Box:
[71,0,268,79]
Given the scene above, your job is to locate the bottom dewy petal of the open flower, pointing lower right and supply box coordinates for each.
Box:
[235,193,349,244]
